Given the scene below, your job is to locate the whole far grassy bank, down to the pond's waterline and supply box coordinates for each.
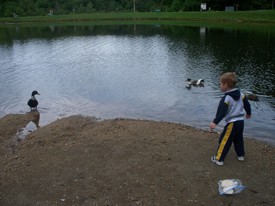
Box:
[0,10,275,32]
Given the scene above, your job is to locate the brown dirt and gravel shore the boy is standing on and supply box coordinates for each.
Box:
[0,114,275,206]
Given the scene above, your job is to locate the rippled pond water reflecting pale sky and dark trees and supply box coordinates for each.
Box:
[0,25,275,144]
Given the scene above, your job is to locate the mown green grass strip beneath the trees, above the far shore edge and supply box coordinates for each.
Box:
[0,10,275,24]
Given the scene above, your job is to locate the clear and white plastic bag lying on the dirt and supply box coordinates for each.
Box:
[218,179,245,195]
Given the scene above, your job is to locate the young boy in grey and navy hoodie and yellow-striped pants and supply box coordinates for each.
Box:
[210,72,251,166]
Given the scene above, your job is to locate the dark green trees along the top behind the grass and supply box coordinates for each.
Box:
[0,0,274,17]
